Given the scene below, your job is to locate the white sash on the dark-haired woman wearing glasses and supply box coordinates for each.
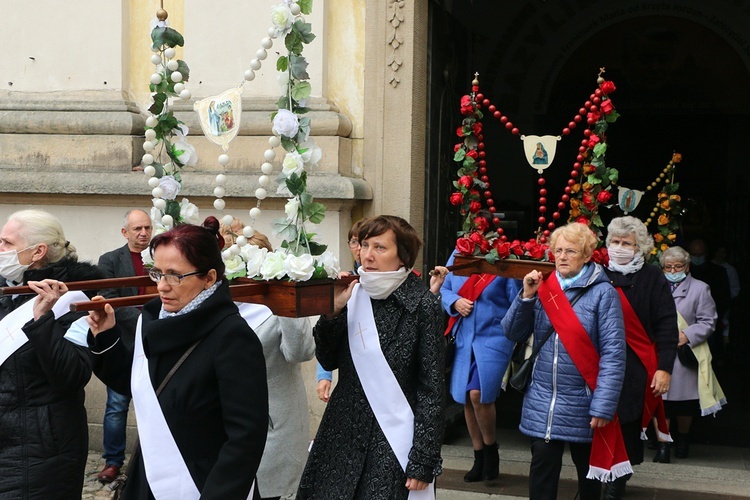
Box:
[130,316,255,500]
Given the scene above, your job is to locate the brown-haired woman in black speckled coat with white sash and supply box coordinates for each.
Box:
[297,216,445,500]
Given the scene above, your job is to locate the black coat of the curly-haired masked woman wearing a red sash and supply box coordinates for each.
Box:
[606,264,679,424]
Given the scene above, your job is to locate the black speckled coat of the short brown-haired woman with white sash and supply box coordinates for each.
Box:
[297,274,445,500]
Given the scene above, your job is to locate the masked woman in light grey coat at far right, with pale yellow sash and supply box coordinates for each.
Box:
[654,247,721,462]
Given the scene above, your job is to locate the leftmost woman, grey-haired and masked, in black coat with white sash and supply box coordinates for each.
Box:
[0,210,104,499]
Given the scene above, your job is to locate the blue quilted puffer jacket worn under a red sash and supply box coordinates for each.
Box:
[502,264,625,442]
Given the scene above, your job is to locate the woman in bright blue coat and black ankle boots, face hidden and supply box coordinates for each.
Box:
[440,254,521,482]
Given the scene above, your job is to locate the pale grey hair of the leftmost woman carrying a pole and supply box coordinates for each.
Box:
[8,209,78,265]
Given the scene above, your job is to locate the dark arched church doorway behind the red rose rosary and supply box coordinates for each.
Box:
[425,0,750,447]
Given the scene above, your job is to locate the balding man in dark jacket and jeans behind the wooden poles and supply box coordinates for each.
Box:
[96,210,152,483]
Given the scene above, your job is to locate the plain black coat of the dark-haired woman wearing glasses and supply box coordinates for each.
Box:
[89,281,268,500]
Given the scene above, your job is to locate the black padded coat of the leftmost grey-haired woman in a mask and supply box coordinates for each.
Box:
[0,259,101,499]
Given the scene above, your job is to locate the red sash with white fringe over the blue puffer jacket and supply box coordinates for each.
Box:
[538,274,633,482]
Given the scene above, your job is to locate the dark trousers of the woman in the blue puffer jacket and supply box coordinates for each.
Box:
[529,438,601,500]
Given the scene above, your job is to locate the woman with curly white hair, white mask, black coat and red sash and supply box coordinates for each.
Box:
[604,216,677,499]
